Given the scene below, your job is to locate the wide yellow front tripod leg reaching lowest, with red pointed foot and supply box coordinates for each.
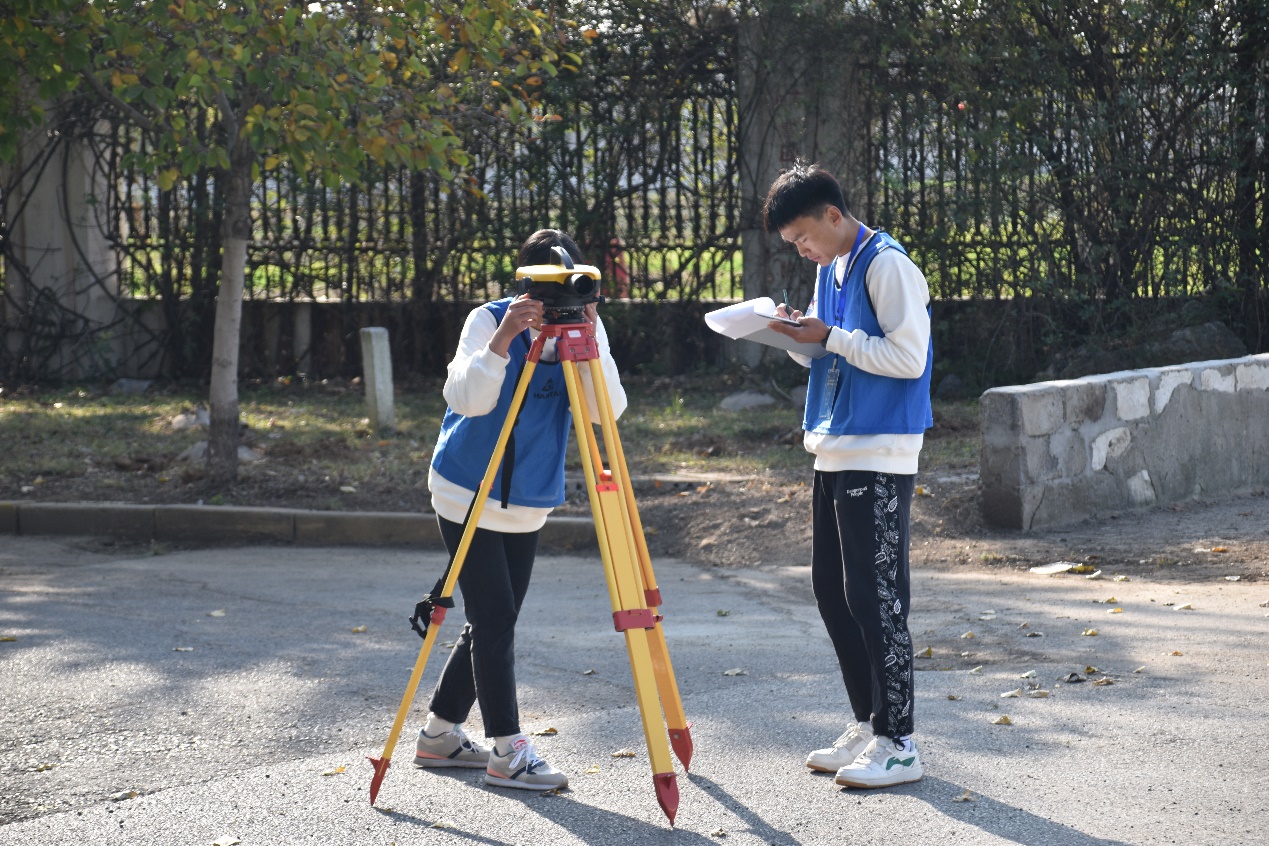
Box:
[562,360,679,824]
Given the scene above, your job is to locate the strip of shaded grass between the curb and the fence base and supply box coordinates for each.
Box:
[0,374,978,510]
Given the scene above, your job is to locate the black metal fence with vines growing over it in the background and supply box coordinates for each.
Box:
[0,0,1269,383]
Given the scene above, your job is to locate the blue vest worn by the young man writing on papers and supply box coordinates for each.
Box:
[802,232,934,435]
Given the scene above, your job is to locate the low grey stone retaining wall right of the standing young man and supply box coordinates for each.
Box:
[980,354,1269,529]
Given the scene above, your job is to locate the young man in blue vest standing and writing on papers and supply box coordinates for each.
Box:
[763,164,933,788]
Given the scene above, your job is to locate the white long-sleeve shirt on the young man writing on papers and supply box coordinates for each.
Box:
[789,243,930,476]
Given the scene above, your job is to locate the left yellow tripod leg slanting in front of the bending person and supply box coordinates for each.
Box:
[367,350,546,805]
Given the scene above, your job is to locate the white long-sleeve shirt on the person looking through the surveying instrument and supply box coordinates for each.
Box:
[428,307,627,533]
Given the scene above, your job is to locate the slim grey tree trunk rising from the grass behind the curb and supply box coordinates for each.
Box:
[207,138,253,487]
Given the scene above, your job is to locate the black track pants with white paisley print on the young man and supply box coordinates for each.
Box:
[811,471,916,737]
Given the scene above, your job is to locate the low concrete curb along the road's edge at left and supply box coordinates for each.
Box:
[0,501,596,550]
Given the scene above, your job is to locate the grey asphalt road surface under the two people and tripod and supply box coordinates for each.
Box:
[0,537,1269,846]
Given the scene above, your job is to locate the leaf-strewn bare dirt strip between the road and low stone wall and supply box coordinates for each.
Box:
[604,469,1269,581]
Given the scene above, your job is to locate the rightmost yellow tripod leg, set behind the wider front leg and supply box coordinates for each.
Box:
[590,359,693,770]
